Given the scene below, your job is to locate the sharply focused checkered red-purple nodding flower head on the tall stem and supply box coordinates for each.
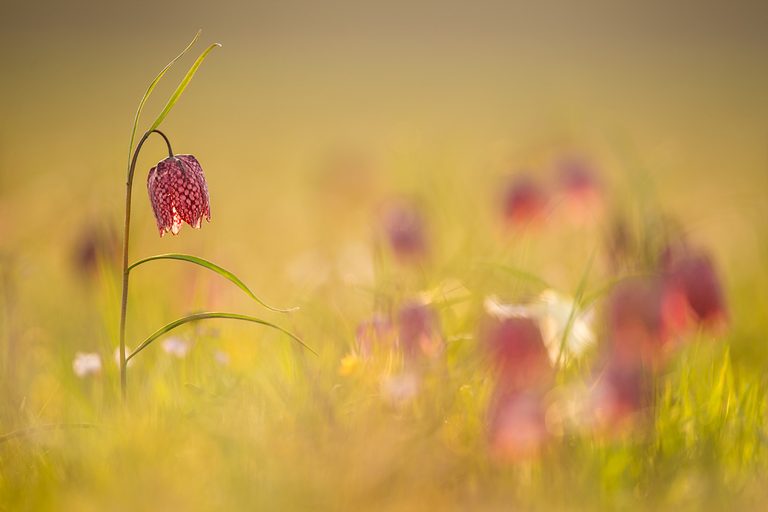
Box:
[147,155,211,236]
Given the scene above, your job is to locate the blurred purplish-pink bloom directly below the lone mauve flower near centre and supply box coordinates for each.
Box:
[397,301,445,358]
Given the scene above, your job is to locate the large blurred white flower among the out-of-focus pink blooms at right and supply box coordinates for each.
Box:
[484,290,595,363]
